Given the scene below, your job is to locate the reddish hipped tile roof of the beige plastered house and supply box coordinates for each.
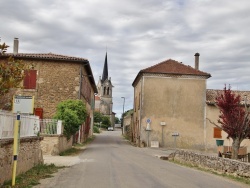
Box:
[132,59,211,85]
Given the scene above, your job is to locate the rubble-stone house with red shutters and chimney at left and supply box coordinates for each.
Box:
[0,39,97,141]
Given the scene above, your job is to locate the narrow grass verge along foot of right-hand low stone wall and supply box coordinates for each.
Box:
[168,160,250,185]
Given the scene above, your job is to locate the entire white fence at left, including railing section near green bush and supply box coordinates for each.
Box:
[0,111,62,139]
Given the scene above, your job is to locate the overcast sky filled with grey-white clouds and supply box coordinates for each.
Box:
[0,0,250,117]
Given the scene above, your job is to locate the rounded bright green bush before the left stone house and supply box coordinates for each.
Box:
[55,99,87,139]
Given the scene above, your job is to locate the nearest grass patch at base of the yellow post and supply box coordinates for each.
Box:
[2,164,64,188]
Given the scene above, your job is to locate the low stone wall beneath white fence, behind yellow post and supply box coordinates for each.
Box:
[0,137,43,185]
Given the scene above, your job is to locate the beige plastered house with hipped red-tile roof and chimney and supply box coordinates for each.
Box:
[132,53,211,149]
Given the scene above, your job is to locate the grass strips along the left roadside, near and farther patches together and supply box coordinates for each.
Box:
[0,136,95,188]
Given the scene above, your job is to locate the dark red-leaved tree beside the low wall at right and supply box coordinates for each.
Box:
[209,86,250,159]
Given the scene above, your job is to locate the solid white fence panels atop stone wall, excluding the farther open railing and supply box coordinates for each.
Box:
[0,111,40,139]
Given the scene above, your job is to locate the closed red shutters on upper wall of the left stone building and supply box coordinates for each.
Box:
[23,70,37,89]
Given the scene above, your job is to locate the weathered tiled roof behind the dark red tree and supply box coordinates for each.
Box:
[206,89,250,105]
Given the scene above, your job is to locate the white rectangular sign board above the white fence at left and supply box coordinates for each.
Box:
[12,95,34,114]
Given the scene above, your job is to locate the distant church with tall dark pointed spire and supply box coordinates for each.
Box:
[95,53,115,126]
